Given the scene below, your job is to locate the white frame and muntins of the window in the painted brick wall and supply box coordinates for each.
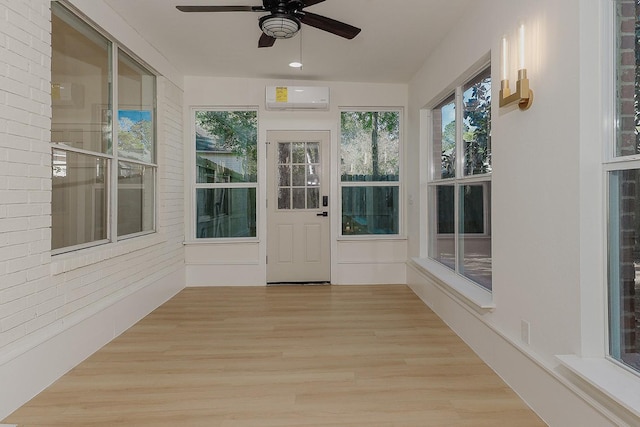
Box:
[49,0,160,256]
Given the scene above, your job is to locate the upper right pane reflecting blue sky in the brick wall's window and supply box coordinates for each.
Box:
[118,51,156,163]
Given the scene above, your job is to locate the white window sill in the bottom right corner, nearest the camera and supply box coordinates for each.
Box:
[556,354,640,418]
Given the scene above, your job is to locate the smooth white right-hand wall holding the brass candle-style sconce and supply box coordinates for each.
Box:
[407,0,640,426]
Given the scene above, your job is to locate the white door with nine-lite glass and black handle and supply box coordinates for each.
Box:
[267,131,331,283]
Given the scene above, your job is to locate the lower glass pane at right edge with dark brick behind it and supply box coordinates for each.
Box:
[608,169,640,370]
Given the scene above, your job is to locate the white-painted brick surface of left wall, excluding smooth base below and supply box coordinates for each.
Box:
[0,0,184,360]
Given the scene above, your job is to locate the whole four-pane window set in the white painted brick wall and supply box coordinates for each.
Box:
[51,2,156,253]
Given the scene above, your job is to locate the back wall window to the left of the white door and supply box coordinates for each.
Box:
[194,110,258,239]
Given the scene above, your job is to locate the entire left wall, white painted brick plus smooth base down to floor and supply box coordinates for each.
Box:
[0,0,184,419]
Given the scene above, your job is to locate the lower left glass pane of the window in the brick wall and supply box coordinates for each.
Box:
[51,149,109,249]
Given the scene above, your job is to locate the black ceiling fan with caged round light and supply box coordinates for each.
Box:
[176,0,360,47]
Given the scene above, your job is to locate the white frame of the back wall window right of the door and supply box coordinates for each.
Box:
[336,107,405,241]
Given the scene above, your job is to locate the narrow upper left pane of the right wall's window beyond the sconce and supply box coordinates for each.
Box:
[431,95,456,179]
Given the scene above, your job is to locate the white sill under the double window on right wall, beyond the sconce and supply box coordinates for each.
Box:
[410,258,496,313]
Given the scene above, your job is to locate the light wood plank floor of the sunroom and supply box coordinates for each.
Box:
[3,286,544,427]
